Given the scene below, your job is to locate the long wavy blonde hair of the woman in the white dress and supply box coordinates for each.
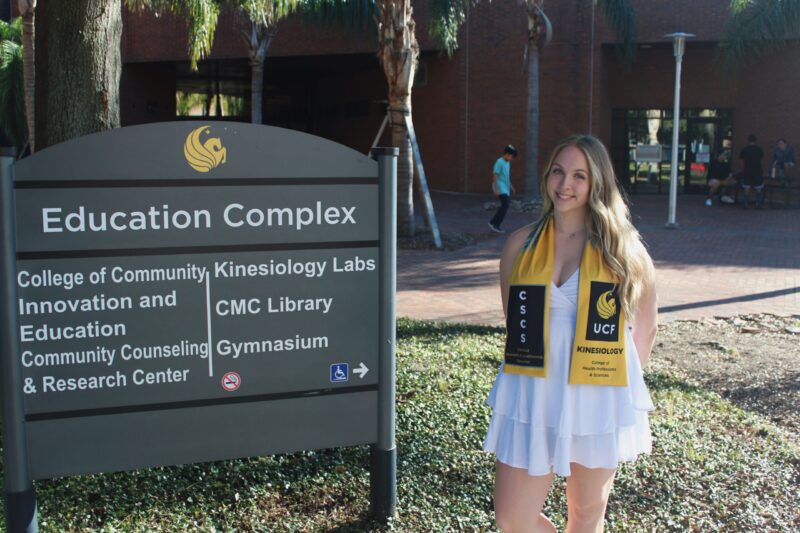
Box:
[540,135,653,318]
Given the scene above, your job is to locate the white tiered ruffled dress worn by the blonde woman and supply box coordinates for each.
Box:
[483,271,653,476]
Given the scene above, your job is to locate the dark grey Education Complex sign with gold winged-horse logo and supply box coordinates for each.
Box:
[2,122,396,522]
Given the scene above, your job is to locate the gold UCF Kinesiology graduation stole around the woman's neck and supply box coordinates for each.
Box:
[504,217,628,387]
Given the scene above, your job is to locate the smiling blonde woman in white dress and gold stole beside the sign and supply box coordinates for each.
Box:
[483,135,657,533]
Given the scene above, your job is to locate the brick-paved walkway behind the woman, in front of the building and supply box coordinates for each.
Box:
[397,193,800,326]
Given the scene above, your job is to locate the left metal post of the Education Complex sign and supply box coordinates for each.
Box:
[0,148,39,533]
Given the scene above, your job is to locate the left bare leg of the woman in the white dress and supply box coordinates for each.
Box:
[494,461,556,533]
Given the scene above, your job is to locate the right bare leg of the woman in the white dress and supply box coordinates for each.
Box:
[567,463,616,533]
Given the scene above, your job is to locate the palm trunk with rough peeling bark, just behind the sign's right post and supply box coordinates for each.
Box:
[378,0,419,237]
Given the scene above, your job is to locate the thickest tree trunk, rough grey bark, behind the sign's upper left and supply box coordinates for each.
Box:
[36,0,122,149]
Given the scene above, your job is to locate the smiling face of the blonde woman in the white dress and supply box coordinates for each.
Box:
[547,146,591,214]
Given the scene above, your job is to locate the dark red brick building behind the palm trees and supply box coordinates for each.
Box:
[6,0,800,193]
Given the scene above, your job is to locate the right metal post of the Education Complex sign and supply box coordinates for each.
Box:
[370,148,399,521]
